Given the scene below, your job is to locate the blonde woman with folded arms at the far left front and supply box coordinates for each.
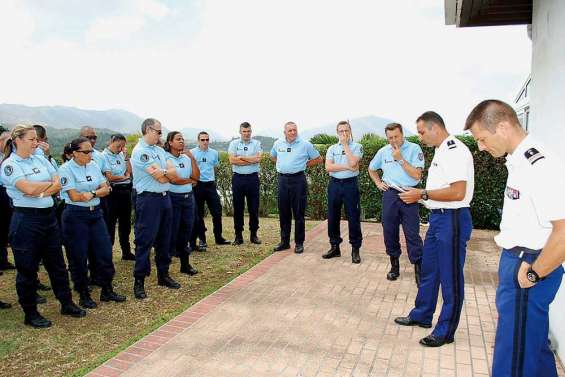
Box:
[0,125,86,328]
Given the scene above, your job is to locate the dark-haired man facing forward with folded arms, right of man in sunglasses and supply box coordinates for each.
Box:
[228,122,263,245]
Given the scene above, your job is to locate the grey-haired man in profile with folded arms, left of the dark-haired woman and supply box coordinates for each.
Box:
[131,118,180,299]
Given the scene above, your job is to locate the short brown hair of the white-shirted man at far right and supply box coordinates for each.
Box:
[465,99,522,133]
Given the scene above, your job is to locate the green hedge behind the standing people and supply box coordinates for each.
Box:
[217,136,507,229]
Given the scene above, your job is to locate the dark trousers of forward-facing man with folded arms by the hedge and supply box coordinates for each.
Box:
[231,173,259,234]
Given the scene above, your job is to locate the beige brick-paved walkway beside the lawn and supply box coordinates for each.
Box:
[90,223,565,377]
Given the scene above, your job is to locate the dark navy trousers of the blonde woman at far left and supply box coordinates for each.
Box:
[9,208,72,311]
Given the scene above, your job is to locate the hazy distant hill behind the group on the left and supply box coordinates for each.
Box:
[0,104,143,133]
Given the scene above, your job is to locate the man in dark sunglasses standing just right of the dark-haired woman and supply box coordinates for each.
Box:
[190,131,230,251]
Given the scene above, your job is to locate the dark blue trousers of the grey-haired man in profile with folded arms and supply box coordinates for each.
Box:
[133,192,173,279]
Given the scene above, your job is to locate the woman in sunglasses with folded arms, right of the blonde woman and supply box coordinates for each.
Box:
[59,137,126,309]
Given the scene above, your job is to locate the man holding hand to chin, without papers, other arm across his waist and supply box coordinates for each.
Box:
[322,121,363,264]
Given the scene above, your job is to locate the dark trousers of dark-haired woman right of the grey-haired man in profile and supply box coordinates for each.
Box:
[169,192,196,258]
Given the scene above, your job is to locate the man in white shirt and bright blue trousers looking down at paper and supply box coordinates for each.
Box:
[394,111,475,347]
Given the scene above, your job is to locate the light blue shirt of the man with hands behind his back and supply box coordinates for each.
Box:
[271,138,320,174]
